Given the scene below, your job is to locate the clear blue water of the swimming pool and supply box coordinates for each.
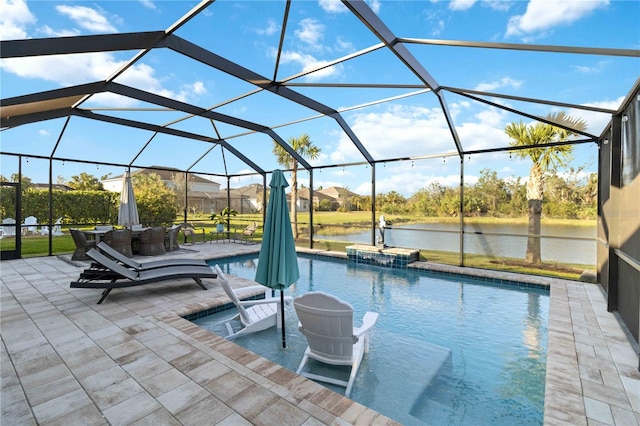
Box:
[193,257,549,425]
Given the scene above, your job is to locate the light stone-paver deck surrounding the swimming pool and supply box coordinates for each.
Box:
[0,243,640,426]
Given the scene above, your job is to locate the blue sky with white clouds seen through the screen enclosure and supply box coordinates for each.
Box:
[0,0,640,196]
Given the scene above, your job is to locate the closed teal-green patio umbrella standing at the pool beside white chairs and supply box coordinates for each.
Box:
[256,170,300,348]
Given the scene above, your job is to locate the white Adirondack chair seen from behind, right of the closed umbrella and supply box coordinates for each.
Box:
[293,291,378,397]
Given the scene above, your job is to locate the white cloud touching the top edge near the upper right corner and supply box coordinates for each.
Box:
[506,0,609,37]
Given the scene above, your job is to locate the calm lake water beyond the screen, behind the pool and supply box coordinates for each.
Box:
[314,223,596,265]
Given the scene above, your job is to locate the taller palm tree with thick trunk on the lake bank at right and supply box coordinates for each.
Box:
[504,112,587,264]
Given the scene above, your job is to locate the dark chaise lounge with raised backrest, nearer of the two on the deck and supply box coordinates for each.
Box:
[71,249,217,304]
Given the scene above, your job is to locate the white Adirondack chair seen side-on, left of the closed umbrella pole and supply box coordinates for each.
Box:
[215,265,293,340]
